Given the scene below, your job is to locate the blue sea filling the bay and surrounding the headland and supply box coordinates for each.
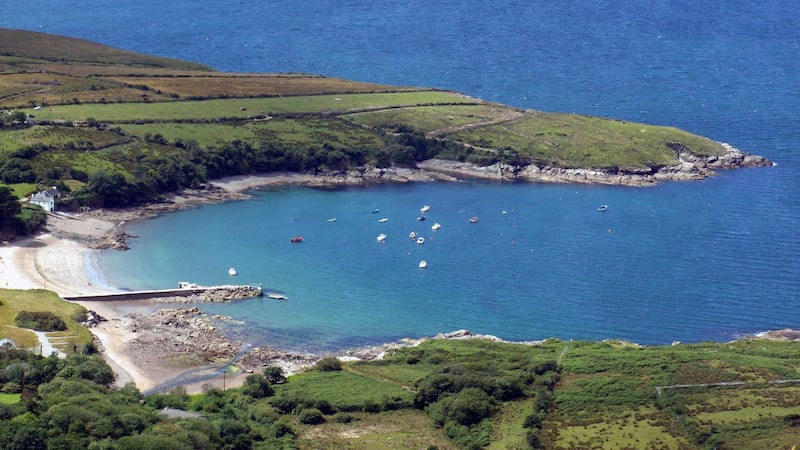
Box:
[0,0,800,352]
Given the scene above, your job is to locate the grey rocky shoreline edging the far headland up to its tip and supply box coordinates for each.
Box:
[48,143,774,250]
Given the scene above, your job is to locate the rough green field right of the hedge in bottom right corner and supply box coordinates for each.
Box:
[543,340,800,449]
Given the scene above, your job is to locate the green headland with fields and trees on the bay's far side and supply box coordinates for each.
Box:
[0,30,723,239]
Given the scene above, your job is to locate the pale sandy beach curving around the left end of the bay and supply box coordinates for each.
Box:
[0,175,316,392]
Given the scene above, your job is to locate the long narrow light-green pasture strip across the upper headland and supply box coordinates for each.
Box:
[22,91,475,122]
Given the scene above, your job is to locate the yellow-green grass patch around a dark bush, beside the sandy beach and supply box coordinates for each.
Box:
[0,289,92,353]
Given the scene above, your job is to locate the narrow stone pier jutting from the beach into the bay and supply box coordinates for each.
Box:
[64,281,264,302]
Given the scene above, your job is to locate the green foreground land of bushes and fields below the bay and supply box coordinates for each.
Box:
[0,324,800,449]
